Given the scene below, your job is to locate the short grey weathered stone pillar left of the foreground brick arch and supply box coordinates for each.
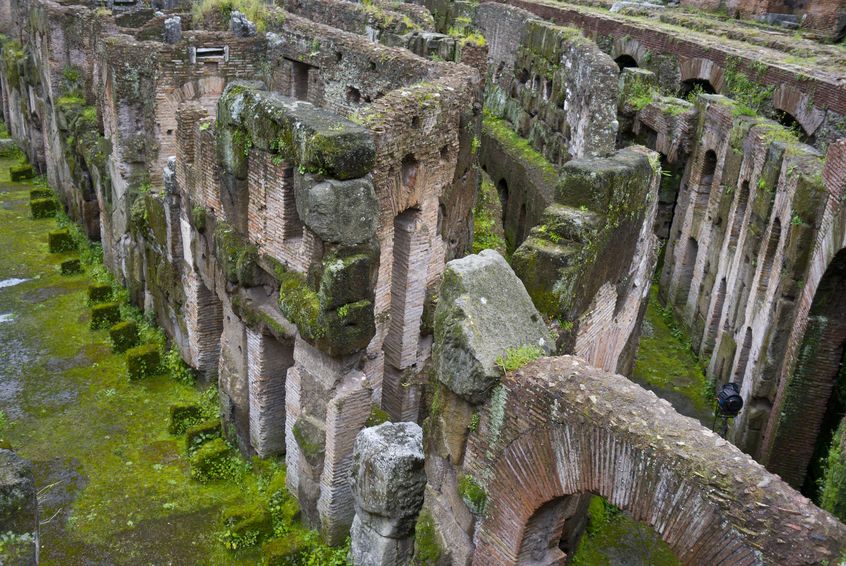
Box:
[349,422,426,566]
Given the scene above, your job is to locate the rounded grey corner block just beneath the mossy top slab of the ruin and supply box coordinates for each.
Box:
[294,173,379,246]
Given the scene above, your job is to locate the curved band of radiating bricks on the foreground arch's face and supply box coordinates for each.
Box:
[474,423,761,565]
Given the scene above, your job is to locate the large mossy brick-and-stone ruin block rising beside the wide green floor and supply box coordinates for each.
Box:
[2,3,481,543]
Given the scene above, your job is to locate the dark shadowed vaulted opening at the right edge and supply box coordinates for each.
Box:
[770,249,846,496]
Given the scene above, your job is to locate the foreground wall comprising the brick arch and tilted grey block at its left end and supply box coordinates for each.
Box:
[417,252,846,565]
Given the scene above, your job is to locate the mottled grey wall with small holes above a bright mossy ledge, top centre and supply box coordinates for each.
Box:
[475,3,617,253]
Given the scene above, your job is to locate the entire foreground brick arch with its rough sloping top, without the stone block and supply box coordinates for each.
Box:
[464,356,846,566]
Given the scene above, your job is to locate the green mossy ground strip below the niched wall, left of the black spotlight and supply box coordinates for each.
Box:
[632,285,714,427]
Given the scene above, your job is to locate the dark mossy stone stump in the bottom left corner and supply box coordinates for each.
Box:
[0,449,38,565]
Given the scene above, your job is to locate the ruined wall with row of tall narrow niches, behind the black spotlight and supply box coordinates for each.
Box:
[661,96,834,485]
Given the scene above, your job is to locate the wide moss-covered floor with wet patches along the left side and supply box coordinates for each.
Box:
[0,154,343,566]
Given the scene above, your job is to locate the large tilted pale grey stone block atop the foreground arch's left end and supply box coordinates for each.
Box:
[434,250,554,403]
